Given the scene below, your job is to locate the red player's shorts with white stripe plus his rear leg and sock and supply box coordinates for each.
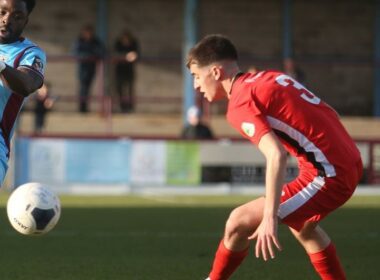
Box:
[279,171,361,280]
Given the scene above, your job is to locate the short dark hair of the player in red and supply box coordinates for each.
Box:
[186,34,238,67]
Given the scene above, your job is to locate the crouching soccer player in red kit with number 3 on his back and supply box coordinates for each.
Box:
[187,35,362,280]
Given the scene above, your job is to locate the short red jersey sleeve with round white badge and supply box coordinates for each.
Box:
[227,102,272,145]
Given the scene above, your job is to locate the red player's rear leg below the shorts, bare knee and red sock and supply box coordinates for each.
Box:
[290,222,346,280]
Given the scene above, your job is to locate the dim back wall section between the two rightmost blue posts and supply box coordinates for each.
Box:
[294,0,375,115]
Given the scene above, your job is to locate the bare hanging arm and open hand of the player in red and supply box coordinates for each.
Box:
[250,132,287,260]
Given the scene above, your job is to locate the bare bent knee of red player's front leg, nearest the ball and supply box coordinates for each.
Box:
[225,208,252,238]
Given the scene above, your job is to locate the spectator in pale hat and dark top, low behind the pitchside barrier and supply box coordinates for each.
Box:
[181,106,214,139]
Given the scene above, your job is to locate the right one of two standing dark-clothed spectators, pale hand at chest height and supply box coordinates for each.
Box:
[115,30,139,113]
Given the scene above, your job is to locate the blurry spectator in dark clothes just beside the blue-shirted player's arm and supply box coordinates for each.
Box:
[34,83,54,134]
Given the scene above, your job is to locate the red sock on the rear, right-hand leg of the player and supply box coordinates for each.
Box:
[309,242,346,280]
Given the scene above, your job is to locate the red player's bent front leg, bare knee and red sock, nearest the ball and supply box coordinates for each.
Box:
[208,197,265,280]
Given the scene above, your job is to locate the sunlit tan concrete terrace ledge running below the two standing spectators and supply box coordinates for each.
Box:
[18,112,380,139]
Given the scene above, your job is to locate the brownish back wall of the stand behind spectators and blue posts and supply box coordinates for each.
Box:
[25,0,375,115]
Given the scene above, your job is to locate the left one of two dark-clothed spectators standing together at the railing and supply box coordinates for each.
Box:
[74,25,104,113]
